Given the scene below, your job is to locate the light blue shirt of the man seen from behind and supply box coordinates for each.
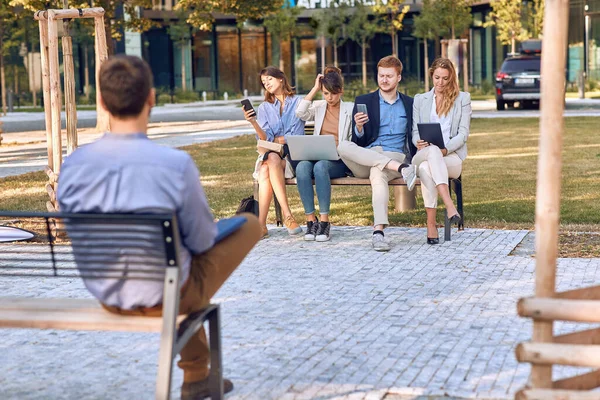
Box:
[57,133,217,309]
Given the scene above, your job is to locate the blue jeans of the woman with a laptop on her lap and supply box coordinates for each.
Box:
[296,160,349,215]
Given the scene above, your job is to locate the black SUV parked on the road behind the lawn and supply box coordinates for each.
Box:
[496,40,541,111]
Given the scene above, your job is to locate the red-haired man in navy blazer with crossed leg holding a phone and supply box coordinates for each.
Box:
[338,56,417,251]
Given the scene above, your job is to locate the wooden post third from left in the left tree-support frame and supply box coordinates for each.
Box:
[62,0,77,155]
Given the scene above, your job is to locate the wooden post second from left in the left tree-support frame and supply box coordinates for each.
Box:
[47,10,62,174]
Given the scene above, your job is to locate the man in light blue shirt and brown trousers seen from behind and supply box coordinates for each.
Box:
[57,55,261,399]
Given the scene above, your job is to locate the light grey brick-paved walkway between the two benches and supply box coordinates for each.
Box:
[0,227,600,400]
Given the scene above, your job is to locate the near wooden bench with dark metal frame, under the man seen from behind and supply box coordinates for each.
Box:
[0,211,223,400]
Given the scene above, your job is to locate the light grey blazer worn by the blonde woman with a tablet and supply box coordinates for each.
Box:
[413,89,471,160]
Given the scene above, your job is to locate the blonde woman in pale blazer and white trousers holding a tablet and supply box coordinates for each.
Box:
[402,58,471,244]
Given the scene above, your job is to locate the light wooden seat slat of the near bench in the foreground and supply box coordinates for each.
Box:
[0,298,185,332]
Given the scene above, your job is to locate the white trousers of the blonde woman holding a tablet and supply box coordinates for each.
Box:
[412,146,462,208]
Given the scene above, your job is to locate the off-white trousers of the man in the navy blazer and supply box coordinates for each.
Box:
[338,141,405,226]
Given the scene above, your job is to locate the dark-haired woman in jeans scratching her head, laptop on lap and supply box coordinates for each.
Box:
[296,67,354,242]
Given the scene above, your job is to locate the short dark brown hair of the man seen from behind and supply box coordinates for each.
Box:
[99,54,153,118]
